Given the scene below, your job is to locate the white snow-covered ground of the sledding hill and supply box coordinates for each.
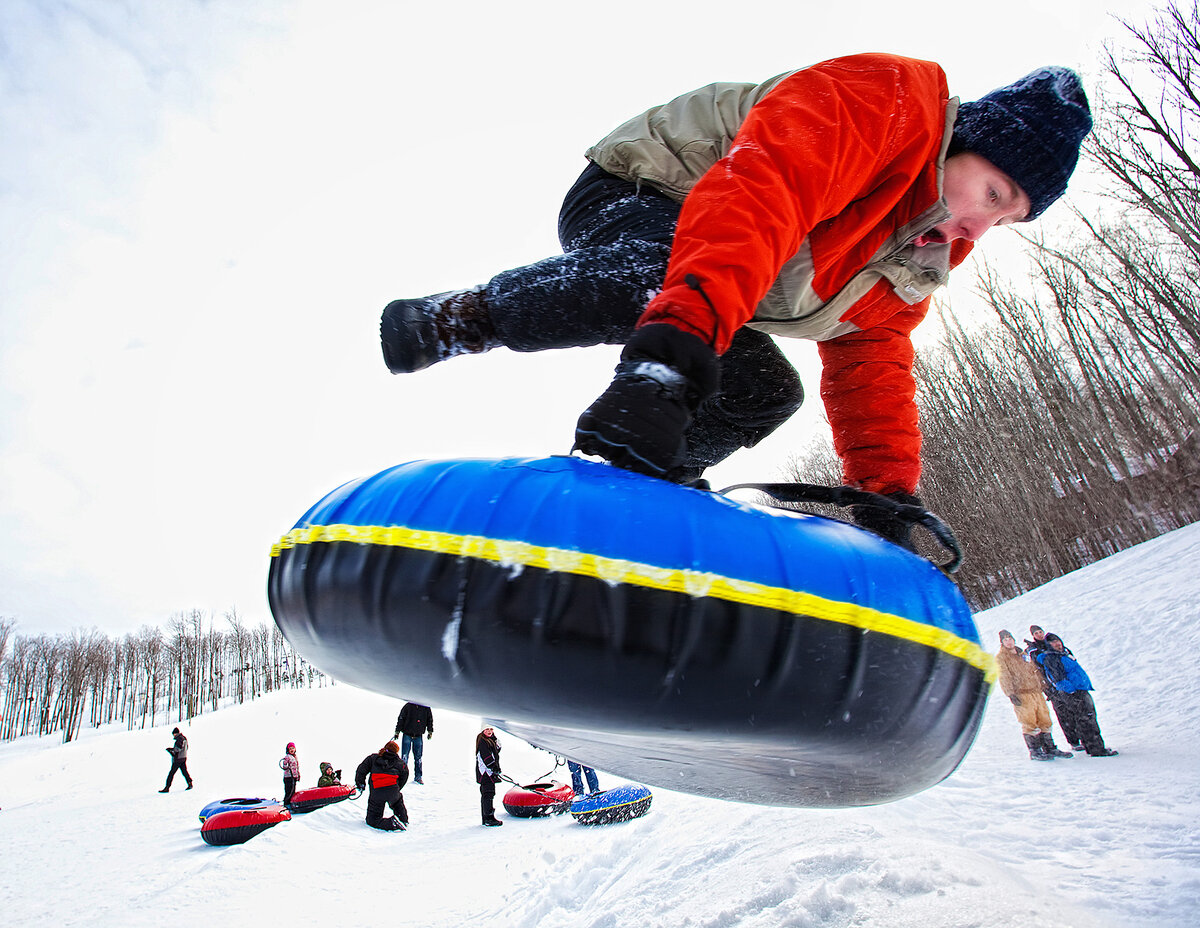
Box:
[0,526,1200,928]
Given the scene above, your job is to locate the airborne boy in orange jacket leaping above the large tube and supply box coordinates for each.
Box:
[379,54,1092,546]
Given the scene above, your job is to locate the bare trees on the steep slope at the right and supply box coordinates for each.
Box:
[792,2,1200,609]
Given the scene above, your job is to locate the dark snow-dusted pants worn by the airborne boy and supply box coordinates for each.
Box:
[485,163,804,475]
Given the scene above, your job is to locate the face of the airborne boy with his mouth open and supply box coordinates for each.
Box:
[914,151,1032,245]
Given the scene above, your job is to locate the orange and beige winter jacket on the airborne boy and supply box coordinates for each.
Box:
[588,54,971,492]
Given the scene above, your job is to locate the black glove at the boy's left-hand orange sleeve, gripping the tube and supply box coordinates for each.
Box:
[572,323,720,479]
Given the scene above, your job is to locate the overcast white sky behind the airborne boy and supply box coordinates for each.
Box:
[0,0,1151,634]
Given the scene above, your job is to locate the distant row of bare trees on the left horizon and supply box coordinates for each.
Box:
[0,610,332,742]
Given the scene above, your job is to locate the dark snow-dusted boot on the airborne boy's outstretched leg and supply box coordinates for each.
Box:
[379,287,500,373]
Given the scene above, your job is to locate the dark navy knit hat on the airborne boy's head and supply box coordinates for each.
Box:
[949,66,1092,222]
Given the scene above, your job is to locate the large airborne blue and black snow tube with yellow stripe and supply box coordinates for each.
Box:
[268,457,992,808]
